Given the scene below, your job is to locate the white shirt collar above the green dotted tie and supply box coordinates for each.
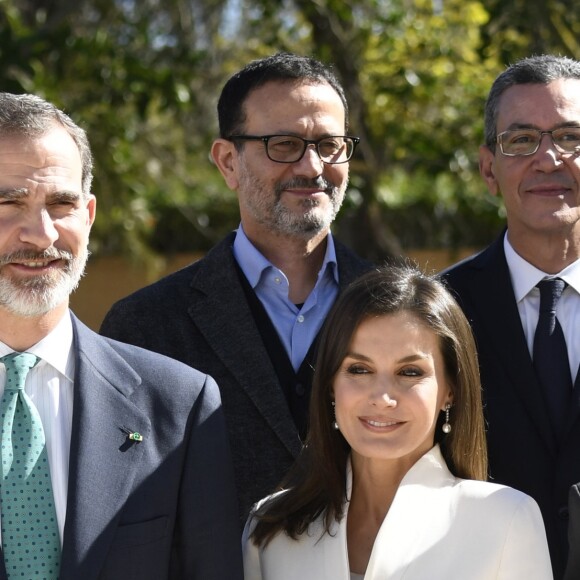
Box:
[0,310,74,381]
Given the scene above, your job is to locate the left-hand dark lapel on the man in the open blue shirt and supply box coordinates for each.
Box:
[189,235,301,456]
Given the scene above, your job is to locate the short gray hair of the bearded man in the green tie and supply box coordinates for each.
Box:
[0,92,93,196]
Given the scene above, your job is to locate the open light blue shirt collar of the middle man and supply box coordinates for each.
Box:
[233,224,338,289]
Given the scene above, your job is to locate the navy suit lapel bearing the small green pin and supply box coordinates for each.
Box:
[60,319,151,580]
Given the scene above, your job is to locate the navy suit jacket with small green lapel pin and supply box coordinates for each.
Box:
[0,316,242,580]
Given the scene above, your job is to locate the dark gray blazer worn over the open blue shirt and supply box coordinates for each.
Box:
[101,233,371,525]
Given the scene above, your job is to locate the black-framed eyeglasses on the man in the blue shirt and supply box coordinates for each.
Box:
[230,135,360,164]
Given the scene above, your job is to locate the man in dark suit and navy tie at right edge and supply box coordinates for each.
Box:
[443,56,580,578]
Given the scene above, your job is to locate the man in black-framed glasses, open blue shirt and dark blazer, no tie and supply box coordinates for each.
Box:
[101,54,370,525]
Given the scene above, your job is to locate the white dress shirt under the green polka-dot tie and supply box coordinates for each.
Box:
[0,311,75,545]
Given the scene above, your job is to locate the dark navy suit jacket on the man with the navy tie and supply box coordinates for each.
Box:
[442,235,580,579]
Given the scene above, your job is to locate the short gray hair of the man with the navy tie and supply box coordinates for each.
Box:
[485,54,580,152]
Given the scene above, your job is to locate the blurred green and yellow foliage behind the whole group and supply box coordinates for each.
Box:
[0,0,580,261]
